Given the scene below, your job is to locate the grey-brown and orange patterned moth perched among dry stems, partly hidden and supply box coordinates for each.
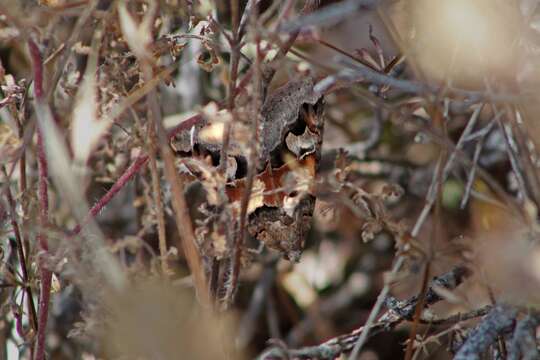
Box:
[171,77,324,262]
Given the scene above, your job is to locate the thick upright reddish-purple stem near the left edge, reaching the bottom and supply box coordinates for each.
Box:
[28,39,52,360]
